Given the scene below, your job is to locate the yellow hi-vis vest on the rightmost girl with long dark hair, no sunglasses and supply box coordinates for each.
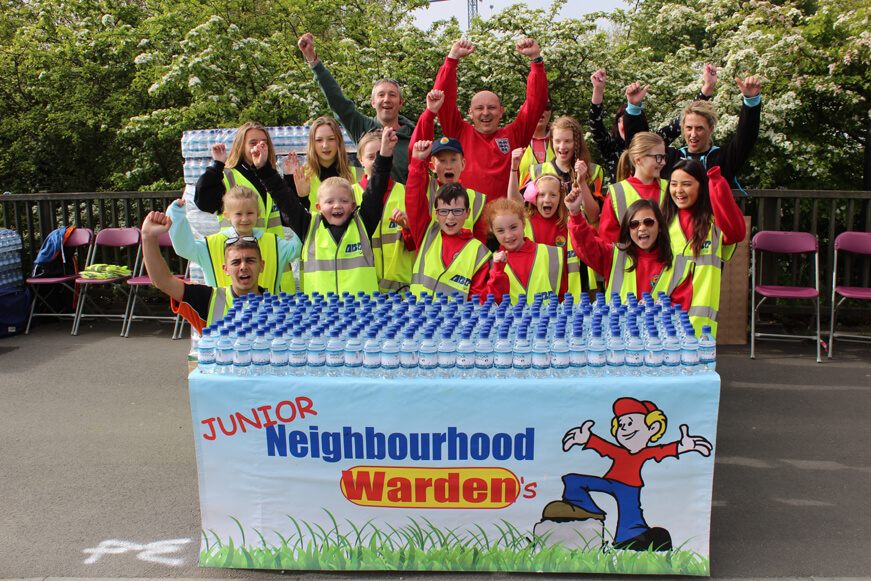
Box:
[668,216,735,337]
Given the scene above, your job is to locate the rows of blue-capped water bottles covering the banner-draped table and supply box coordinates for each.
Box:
[198,293,716,379]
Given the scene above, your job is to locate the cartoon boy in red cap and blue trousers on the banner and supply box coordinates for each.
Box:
[542,397,712,551]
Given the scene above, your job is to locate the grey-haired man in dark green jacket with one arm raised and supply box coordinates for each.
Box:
[297,32,414,184]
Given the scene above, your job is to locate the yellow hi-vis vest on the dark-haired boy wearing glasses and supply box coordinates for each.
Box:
[411,222,490,298]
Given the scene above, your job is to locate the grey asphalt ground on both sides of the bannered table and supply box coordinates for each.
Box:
[0,321,871,581]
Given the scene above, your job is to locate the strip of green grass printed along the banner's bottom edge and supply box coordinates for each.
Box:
[199,510,710,576]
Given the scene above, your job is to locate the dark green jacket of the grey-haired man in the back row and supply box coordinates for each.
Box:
[312,61,414,184]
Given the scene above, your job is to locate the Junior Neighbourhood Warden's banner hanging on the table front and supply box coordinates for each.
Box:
[190,372,720,575]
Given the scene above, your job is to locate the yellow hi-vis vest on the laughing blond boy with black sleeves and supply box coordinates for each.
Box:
[300,211,378,295]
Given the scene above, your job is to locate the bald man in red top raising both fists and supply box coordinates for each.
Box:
[430,38,548,200]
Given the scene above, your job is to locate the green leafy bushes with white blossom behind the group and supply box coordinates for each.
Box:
[0,0,871,192]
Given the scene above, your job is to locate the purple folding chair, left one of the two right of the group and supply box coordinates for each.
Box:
[750,231,821,363]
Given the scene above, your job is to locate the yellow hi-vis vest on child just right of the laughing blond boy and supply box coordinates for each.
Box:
[354,182,414,293]
